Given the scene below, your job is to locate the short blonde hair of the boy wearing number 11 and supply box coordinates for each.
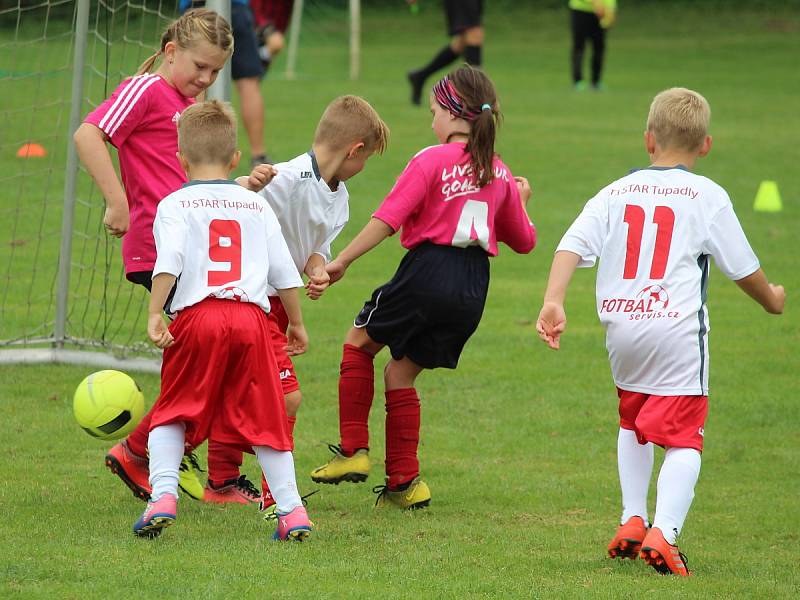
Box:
[647,88,711,152]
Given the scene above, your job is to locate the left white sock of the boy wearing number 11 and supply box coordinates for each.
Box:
[617,427,653,525]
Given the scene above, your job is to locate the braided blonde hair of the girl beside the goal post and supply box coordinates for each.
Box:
[136,8,233,75]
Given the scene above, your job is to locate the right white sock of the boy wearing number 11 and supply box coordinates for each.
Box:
[653,448,701,544]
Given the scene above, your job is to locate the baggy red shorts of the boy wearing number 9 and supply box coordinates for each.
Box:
[150,299,292,452]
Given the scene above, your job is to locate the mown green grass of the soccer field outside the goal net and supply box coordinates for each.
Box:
[0,1,800,600]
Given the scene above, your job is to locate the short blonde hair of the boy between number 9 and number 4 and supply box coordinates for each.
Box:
[314,96,389,154]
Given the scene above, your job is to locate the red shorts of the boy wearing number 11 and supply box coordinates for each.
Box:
[617,388,708,452]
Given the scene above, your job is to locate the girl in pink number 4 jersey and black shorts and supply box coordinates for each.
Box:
[311,65,536,508]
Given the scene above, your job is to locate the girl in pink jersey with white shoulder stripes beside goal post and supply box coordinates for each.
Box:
[74,9,233,499]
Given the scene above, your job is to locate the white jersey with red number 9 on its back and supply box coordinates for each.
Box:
[153,180,303,312]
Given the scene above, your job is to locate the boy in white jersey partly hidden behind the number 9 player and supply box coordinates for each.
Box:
[204,96,389,509]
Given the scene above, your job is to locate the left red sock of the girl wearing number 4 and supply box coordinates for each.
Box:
[339,344,375,456]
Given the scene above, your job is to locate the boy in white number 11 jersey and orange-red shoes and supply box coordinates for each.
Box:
[536,88,785,576]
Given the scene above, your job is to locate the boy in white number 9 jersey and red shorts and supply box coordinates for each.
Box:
[133,102,311,540]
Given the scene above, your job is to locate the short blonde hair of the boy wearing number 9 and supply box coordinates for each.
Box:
[178,100,236,165]
